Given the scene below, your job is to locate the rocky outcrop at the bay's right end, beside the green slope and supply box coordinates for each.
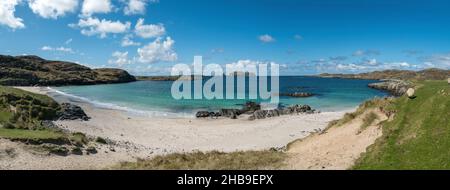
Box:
[368,79,411,96]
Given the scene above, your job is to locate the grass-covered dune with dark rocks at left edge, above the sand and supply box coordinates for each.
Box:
[0,86,88,150]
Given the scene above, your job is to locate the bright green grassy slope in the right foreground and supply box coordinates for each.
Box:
[354,81,450,169]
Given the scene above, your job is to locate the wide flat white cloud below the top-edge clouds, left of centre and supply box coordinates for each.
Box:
[69,17,131,38]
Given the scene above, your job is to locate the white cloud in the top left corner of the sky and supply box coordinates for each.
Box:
[0,0,25,29]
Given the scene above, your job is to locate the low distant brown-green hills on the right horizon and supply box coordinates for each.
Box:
[319,69,450,80]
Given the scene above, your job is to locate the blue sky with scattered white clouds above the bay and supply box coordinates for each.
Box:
[0,0,450,75]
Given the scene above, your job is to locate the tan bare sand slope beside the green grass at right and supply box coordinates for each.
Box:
[286,109,388,170]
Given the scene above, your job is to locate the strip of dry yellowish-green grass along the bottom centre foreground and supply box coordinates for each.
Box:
[114,151,286,170]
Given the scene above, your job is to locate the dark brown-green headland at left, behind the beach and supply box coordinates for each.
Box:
[0,55,136,86]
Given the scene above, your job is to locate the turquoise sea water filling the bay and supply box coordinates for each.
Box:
[53,76,386,117]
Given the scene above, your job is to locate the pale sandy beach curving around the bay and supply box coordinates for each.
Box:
[0,87,353,169]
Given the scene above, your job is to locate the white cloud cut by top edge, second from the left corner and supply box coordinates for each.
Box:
[28,0,78,19]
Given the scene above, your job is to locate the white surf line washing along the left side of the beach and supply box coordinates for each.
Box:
[47,87,194,118]
